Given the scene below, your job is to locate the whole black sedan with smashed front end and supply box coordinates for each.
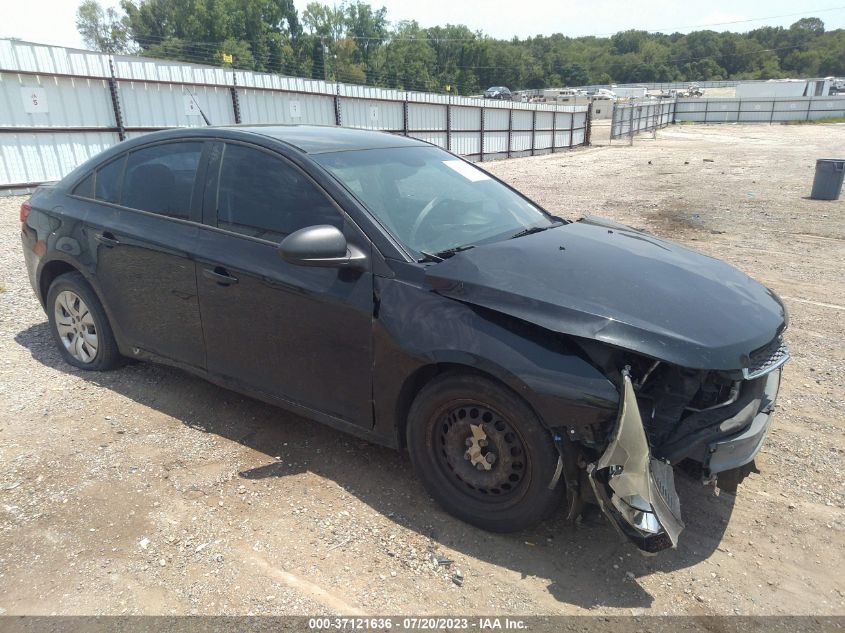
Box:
[21,126,788,551]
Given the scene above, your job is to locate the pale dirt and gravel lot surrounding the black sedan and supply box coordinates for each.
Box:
[0,125,845,615]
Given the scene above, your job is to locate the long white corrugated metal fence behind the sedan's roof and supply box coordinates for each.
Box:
[0,40,590,192]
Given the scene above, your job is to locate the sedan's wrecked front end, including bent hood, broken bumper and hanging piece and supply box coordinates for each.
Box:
[426,217,789,553]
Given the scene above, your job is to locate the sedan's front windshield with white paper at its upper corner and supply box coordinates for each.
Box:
[314,147,560,257]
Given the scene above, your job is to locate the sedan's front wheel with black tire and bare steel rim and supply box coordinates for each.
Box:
[407,373,565,532]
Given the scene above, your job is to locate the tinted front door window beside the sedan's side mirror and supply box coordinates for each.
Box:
[217,144,343,242]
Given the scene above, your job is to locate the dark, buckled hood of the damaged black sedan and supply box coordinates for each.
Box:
[426,216,786,370]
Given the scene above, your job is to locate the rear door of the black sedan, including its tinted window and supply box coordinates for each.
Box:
[86,141,206,368]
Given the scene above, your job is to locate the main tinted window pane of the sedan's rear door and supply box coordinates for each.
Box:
[121,141,203,219]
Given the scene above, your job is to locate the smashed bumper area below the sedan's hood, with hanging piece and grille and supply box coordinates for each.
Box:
[586,336,789,554]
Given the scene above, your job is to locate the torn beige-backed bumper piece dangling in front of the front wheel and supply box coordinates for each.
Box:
[587,371,684,554]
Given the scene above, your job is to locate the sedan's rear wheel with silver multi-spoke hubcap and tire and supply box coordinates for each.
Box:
[46,272,123,371]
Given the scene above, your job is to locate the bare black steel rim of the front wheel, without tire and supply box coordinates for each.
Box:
[432,402,527,502]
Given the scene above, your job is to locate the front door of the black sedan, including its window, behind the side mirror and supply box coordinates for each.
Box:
[197,142,373,427]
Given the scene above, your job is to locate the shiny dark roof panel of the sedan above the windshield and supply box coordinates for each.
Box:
[226,125,428,154]
